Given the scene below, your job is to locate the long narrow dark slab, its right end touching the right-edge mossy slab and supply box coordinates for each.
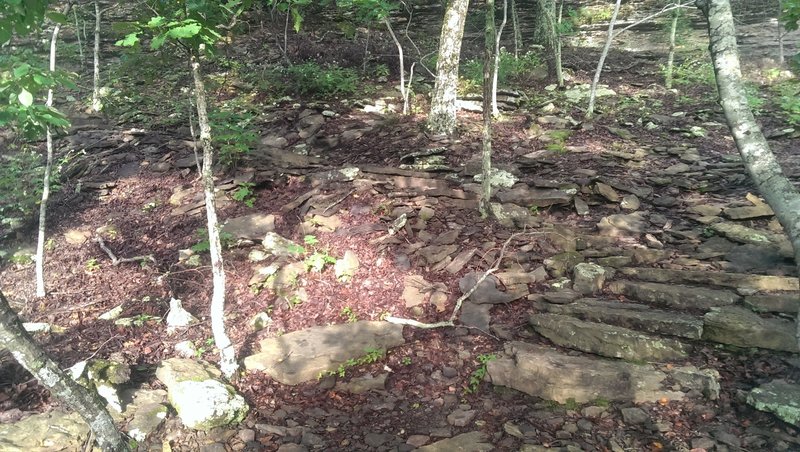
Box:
[544,298,703,339]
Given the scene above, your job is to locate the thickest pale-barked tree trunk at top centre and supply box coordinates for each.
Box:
[428,0,469,135]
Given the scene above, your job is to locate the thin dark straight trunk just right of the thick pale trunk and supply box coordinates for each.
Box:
[480,0,497,218]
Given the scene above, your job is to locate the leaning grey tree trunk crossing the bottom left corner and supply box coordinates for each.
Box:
[0,292,130,451]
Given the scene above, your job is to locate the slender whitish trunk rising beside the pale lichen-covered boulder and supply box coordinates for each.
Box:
[190,45,239,379]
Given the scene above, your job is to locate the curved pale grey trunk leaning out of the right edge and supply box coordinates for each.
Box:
[695,0,800,342]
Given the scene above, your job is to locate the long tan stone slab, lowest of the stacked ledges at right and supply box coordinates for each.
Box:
[487,341,719,403]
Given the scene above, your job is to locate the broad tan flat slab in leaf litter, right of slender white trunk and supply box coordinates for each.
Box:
[244,321,405,385]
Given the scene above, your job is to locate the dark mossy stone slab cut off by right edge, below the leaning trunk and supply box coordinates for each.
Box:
[703,306,800,353]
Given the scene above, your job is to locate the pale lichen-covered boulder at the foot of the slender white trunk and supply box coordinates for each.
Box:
[156,358,249,430]
